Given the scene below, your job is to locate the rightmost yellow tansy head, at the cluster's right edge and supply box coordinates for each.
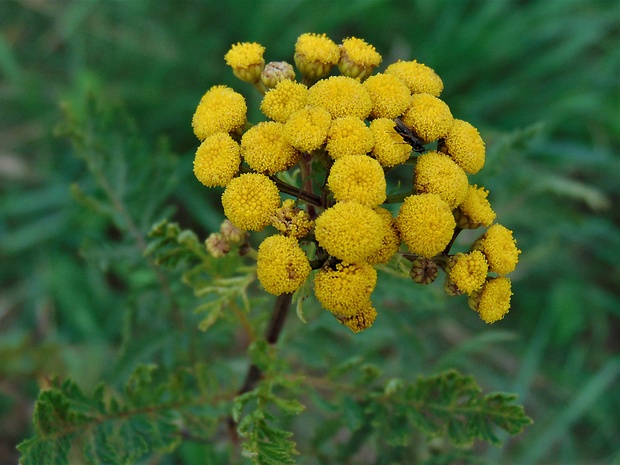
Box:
[473,224,521,275]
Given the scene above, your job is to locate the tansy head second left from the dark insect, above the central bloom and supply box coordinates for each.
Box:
[325,116,374,159]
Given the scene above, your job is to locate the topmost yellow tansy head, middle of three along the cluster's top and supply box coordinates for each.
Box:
[294,33,340,81]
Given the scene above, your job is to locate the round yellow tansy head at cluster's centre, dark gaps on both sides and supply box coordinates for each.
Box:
[327,154,386,207]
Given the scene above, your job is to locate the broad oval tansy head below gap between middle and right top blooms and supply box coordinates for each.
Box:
[308,76,372,119]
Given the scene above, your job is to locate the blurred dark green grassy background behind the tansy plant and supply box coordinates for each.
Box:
[0,0,620,465]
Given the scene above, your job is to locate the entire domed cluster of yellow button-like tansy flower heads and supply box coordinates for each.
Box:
[192,33,520,332]
